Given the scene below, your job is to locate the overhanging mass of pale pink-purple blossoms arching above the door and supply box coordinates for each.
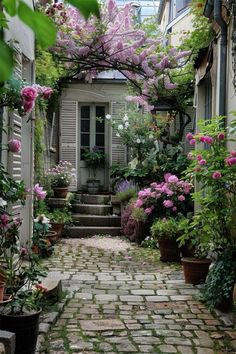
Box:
[45,0,191,109]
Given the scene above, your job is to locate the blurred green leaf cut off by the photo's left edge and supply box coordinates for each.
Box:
[0,40,13,82]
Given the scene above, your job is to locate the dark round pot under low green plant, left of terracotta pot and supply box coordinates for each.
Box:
[158,238,180,262]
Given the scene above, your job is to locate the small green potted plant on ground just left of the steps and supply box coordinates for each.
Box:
[49,208,72,239]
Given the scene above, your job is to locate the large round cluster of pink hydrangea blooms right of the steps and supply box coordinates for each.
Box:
[135,173,192,216]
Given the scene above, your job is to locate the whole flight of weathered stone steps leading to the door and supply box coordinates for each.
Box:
[67,194,121,238]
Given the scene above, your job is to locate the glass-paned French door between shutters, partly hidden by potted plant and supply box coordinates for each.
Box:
[78,103,109,190]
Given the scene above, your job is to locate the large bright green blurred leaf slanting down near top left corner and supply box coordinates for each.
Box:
[18,1,56,49]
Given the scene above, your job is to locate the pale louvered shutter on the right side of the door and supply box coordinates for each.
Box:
[110,102,127,165]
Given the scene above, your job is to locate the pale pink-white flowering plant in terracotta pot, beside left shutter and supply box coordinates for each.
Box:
[46,160,74,198]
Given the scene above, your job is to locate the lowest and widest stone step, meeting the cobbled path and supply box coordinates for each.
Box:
[66,226,121,238]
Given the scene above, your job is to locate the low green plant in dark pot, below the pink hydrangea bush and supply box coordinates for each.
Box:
[151,218,180,262]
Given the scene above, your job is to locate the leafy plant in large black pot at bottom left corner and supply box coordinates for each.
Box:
[0,214,46,354]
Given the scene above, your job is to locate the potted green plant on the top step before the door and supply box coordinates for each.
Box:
[83,146,105,194]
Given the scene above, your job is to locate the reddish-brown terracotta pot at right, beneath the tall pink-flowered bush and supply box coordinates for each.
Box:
[181,257,211,285]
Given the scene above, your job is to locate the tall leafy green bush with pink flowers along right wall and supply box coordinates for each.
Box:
[185,117,236,290]
